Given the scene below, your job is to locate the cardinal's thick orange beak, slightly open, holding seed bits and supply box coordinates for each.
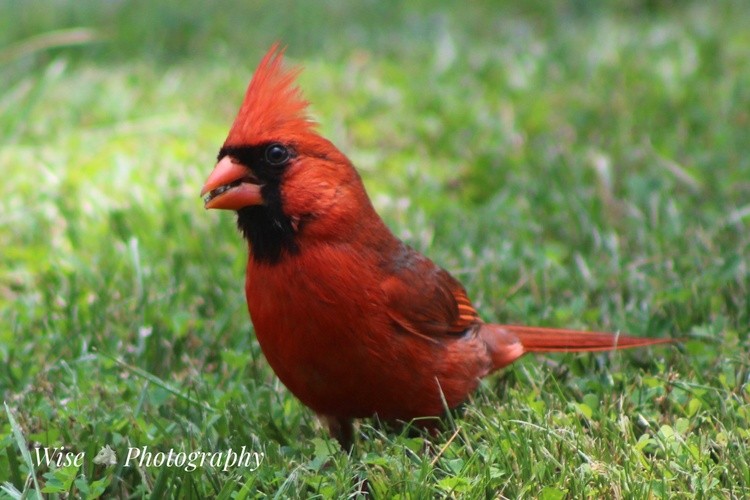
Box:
[201,156,263,210]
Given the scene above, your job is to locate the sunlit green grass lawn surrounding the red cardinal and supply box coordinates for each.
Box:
[0,0,750,499]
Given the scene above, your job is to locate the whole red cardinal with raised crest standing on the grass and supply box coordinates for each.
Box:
[201,45,671,446]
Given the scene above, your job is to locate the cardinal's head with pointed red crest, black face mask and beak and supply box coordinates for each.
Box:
[201,45,371,263]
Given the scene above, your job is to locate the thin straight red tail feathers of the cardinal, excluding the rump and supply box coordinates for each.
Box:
[501,325,674,352]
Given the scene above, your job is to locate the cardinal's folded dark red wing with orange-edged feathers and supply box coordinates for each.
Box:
[380,246,481,340]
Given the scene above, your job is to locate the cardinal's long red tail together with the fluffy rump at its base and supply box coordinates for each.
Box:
[479,324,676,370]
